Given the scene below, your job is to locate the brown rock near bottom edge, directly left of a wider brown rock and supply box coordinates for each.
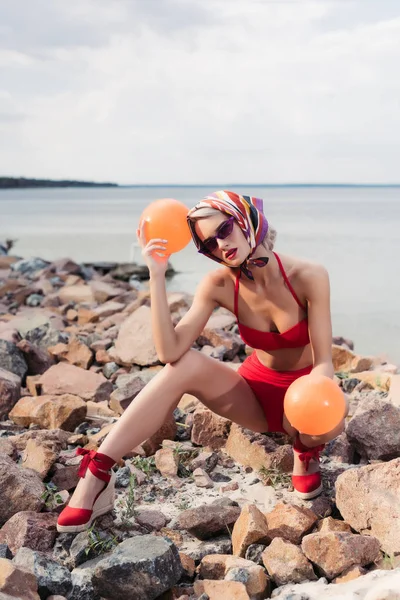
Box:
[262,538,318,586]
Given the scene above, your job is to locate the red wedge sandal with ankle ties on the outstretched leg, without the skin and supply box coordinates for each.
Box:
[57,448,115,533]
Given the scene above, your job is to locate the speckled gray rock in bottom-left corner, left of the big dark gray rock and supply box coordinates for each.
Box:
[13,548,72,600]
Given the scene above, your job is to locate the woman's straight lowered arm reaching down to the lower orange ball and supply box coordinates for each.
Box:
[304,265,335,377]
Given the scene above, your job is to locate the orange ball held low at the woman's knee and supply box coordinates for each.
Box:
[284,374,346,435]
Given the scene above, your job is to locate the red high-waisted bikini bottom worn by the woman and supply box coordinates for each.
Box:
[238,351,313,433]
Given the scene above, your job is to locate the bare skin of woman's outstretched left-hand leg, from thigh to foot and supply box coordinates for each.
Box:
[69,350,268,508]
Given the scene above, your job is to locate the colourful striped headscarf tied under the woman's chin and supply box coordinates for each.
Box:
[188,191,268,279]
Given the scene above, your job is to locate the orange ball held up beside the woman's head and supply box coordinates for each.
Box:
[140,198,192,254]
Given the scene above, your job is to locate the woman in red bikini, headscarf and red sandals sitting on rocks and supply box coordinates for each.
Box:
[57,192,345,532]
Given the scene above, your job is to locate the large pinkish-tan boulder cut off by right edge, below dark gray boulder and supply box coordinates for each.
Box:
[336,458,400,554]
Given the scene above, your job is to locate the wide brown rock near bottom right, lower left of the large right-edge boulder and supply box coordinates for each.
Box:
[301,531,379,579]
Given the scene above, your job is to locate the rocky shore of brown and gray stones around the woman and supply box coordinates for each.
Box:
[0,250,400,600]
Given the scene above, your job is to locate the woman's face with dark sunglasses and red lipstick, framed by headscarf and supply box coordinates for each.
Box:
[195,213,250,267]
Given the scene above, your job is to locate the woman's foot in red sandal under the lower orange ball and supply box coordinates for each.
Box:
[292,436,324,500]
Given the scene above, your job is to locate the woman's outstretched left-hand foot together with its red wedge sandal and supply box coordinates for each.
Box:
[57,449,115,533]
